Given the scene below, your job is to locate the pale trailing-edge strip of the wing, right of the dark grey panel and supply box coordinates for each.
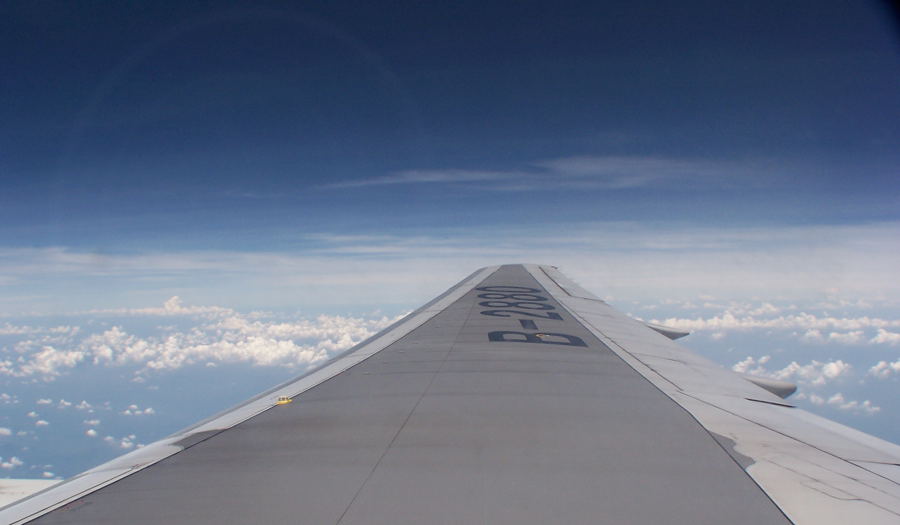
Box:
[528,266,900,524]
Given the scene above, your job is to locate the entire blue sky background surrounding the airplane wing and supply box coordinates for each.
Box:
[0,1,900,475]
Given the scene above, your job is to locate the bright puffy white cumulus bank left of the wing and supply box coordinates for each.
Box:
[0,298,396,378]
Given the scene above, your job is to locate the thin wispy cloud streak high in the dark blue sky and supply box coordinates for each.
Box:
[321,156,756,191]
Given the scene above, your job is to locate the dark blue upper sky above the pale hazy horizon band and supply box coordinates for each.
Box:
[0,1,900,250]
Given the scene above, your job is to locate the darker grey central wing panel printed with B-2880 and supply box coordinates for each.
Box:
[4,265,786,525]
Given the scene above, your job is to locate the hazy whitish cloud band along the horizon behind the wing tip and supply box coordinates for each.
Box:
[0,221,900,316]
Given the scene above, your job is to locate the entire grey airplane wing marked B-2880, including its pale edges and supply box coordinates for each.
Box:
[0,265,900,525]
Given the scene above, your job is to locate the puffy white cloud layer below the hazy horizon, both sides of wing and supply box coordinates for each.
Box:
[0,290,900,477]
